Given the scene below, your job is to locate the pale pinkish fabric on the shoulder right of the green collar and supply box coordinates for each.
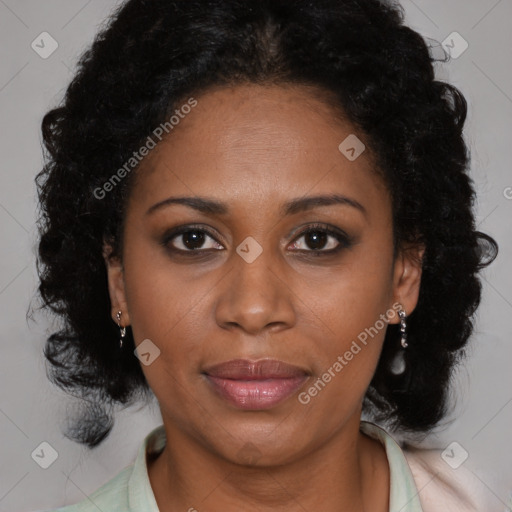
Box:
[403,447,499,512]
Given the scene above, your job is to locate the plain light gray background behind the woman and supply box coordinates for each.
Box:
[0,0,512,512]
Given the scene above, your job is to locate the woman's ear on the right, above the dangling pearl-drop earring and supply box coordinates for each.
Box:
[390,244,425,323]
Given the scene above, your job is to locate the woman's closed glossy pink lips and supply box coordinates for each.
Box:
[204,359,308,410]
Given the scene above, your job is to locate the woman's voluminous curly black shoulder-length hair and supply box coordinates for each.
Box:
[36,0,498,447]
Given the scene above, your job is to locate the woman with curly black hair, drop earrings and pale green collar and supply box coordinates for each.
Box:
[38,0,497,512]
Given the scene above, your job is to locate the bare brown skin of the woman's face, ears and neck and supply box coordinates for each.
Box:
[105,85,422,512]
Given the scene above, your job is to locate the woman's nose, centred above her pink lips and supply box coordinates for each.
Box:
[215,251,296,335]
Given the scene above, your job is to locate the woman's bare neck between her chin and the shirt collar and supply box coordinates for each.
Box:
[148,417,389,512]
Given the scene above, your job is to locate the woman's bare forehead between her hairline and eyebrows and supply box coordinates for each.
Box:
[133,85,389,214]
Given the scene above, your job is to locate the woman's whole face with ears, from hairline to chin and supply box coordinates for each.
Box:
[108,85,420,464]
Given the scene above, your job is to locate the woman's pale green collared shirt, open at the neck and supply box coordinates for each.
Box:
[48,421,423,512]
